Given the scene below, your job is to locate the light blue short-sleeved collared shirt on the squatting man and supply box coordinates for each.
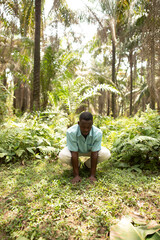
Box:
[67,124,102,153]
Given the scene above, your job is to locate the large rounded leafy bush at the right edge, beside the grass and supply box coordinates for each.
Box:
[112,110,160,169]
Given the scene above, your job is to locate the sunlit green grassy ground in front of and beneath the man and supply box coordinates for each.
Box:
[0,160,160,240]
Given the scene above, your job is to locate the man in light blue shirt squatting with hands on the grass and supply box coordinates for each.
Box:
[59,112,111,183]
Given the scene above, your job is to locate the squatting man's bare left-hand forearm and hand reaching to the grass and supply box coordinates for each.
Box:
[71,152,81,183]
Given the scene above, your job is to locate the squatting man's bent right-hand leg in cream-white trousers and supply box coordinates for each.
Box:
[85,147,111,168]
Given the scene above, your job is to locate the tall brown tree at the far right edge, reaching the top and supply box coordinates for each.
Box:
[141,0,160,110]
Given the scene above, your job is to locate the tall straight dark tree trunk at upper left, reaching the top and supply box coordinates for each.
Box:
[31,0,41,111]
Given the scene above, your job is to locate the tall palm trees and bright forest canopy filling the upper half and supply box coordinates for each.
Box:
[0,0,160,120]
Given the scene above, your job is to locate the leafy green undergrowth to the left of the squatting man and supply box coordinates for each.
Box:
[0,111,65,163]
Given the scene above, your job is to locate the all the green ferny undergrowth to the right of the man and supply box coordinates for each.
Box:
[96,109,160,170]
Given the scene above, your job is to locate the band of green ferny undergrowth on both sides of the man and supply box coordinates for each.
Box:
[0,109,160,170]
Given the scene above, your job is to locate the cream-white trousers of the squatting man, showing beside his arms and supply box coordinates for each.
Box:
[59,147,111,168]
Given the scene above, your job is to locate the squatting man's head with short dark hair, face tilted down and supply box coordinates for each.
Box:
[78,112,93,137]
